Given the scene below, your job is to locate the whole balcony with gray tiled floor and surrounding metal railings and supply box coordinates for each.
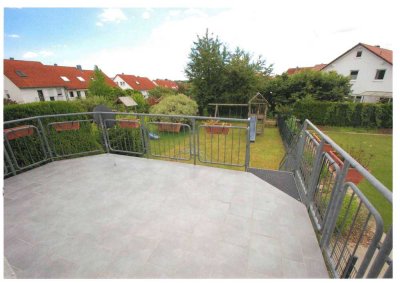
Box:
[4,112,392,278]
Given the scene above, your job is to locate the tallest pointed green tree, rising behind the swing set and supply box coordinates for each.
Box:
[185,30,229,115]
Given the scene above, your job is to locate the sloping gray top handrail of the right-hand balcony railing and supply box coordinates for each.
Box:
[305,119,393,204]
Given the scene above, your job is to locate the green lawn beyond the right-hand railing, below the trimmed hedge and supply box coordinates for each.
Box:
[324,127,393,230]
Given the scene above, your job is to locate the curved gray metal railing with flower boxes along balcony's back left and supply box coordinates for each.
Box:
[4,112,250,177]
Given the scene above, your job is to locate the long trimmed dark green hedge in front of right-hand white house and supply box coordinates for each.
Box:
[293,100,393,128]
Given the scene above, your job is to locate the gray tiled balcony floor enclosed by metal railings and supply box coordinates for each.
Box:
[4,154,328,278]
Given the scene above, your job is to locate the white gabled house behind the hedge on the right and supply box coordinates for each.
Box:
[321,43,393,103]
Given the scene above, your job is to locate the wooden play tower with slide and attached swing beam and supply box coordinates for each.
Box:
[208,92,269,141]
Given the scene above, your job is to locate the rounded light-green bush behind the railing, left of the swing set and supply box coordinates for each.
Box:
[150,94,198,121]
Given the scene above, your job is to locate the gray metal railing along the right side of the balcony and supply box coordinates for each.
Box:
[278,119,393,278]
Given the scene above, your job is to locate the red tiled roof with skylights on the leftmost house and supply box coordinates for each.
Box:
[4,59,117,89]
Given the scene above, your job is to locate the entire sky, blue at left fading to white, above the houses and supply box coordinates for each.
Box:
[3,0,398,80]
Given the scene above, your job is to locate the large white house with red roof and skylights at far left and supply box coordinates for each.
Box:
[4,59,116,103]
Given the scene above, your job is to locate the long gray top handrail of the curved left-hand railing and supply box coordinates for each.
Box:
[3,111,250,125]
